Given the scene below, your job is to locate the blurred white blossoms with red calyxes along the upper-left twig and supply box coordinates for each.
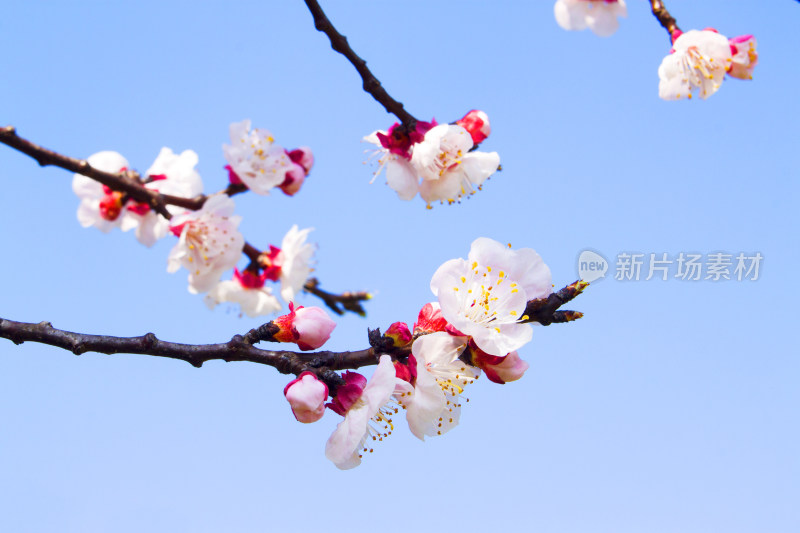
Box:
[72,120,315,317]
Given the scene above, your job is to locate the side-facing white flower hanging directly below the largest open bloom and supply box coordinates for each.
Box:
[398,332,481,440]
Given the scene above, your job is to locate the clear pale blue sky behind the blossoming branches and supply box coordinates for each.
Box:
[0,0,800,533]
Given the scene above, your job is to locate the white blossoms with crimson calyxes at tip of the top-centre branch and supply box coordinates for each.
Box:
[364,110,500,208]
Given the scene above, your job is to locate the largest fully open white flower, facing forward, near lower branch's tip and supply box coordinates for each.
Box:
[431,237,553,356]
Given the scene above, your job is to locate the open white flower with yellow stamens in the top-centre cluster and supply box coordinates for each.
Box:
[411,124,500,206]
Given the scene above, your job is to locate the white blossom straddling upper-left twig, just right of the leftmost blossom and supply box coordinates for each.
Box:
[121,147,203,246]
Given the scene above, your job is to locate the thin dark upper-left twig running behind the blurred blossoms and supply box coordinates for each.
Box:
[0,126,369,316]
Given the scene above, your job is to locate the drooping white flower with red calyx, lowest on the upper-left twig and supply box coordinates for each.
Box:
[204,268,281,318]
